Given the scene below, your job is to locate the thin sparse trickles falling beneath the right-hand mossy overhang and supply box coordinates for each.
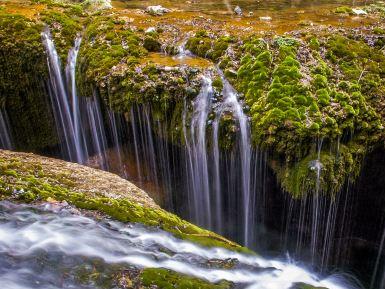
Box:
[282,140,353,271]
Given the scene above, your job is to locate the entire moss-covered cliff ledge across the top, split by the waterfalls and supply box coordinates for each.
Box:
[0,0,385,198]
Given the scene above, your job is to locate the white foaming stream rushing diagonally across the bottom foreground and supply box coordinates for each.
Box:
[0,201,353,289]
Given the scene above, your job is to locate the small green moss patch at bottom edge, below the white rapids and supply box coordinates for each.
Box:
[141,268,232,289]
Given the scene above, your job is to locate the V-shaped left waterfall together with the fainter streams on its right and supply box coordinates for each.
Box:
[42,30,111,170]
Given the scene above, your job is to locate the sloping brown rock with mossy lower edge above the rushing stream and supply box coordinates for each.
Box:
[0,150,251,253]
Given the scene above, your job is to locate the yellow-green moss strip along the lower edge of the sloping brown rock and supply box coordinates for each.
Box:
[0,153,250,252]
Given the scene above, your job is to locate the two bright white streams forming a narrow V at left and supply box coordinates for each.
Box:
[42,30,87,163]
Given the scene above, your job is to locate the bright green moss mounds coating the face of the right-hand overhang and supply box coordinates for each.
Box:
[233,35,383,197]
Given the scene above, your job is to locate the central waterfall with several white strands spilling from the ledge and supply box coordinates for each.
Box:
[182,72,257,245]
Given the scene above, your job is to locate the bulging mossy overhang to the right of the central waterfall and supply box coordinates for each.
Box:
[187,26,385,198]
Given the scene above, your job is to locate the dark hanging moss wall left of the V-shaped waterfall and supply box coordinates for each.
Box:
[0,12,57,151]
